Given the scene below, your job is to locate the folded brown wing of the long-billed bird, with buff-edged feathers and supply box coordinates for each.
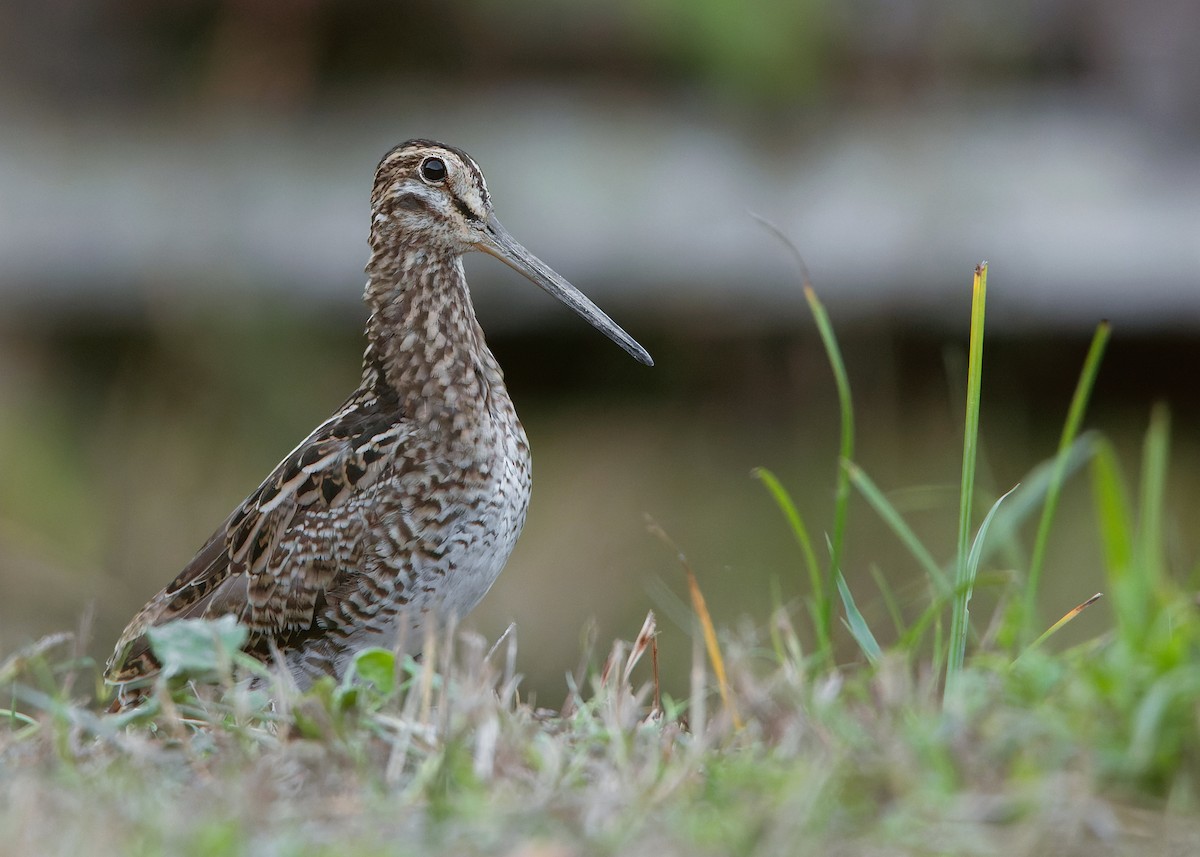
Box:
[106,397,409,685]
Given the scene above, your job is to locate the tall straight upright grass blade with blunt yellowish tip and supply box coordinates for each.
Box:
[946,262,988,688]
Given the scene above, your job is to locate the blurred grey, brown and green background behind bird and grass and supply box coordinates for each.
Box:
[0,0,1200,703]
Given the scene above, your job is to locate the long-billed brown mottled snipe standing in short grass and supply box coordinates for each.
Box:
[104,139,654,711]
